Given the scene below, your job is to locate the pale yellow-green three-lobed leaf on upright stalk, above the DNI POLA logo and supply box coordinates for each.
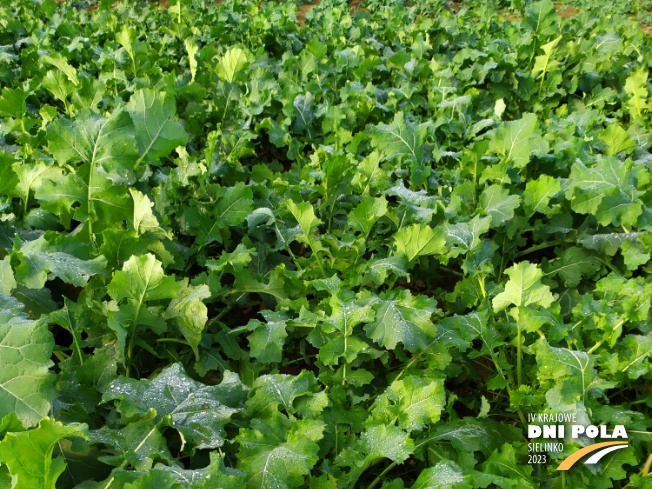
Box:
[493,261,555,312]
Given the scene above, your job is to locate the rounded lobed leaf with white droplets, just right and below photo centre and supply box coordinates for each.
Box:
[364,289,437,353]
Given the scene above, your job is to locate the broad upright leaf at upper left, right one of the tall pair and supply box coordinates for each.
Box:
[127,89,188,162]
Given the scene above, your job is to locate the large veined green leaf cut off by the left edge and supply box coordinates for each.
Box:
[0,294,54,426]
